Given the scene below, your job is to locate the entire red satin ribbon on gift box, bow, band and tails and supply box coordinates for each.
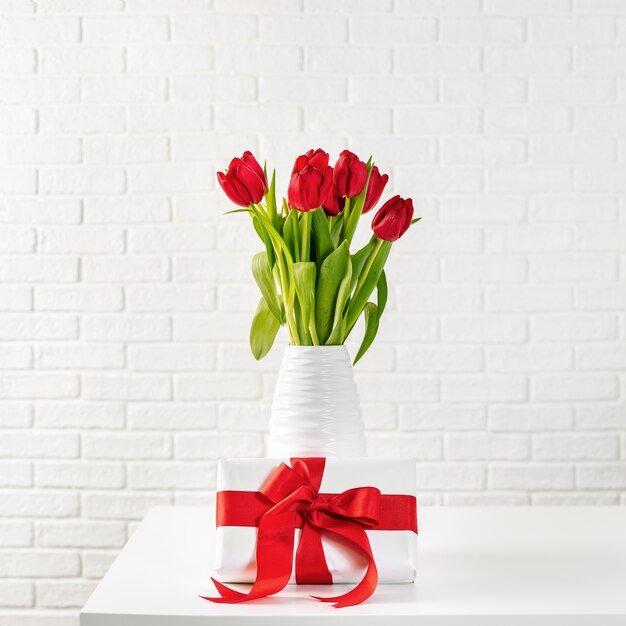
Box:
[201,458,417,607]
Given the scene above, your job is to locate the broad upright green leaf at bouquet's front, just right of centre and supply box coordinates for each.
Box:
[315,241,350,345]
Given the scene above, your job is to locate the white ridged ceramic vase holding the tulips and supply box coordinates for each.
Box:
[268,346,366,458]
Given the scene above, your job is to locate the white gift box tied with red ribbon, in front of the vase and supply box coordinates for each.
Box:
[215,458,417,587]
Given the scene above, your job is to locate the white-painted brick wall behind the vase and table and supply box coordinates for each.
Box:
[0,0,626,626]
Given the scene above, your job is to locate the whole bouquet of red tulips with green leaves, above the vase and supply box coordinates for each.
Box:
[217,149,419,363]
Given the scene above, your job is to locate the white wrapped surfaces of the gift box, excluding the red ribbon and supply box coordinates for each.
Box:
[215,458,417,583]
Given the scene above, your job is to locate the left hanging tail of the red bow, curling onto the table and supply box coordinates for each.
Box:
[200,512,294,604]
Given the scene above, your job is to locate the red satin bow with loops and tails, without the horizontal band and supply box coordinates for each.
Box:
[201,458,381,607]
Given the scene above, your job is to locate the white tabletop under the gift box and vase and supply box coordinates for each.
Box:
[80,507,626,626]
